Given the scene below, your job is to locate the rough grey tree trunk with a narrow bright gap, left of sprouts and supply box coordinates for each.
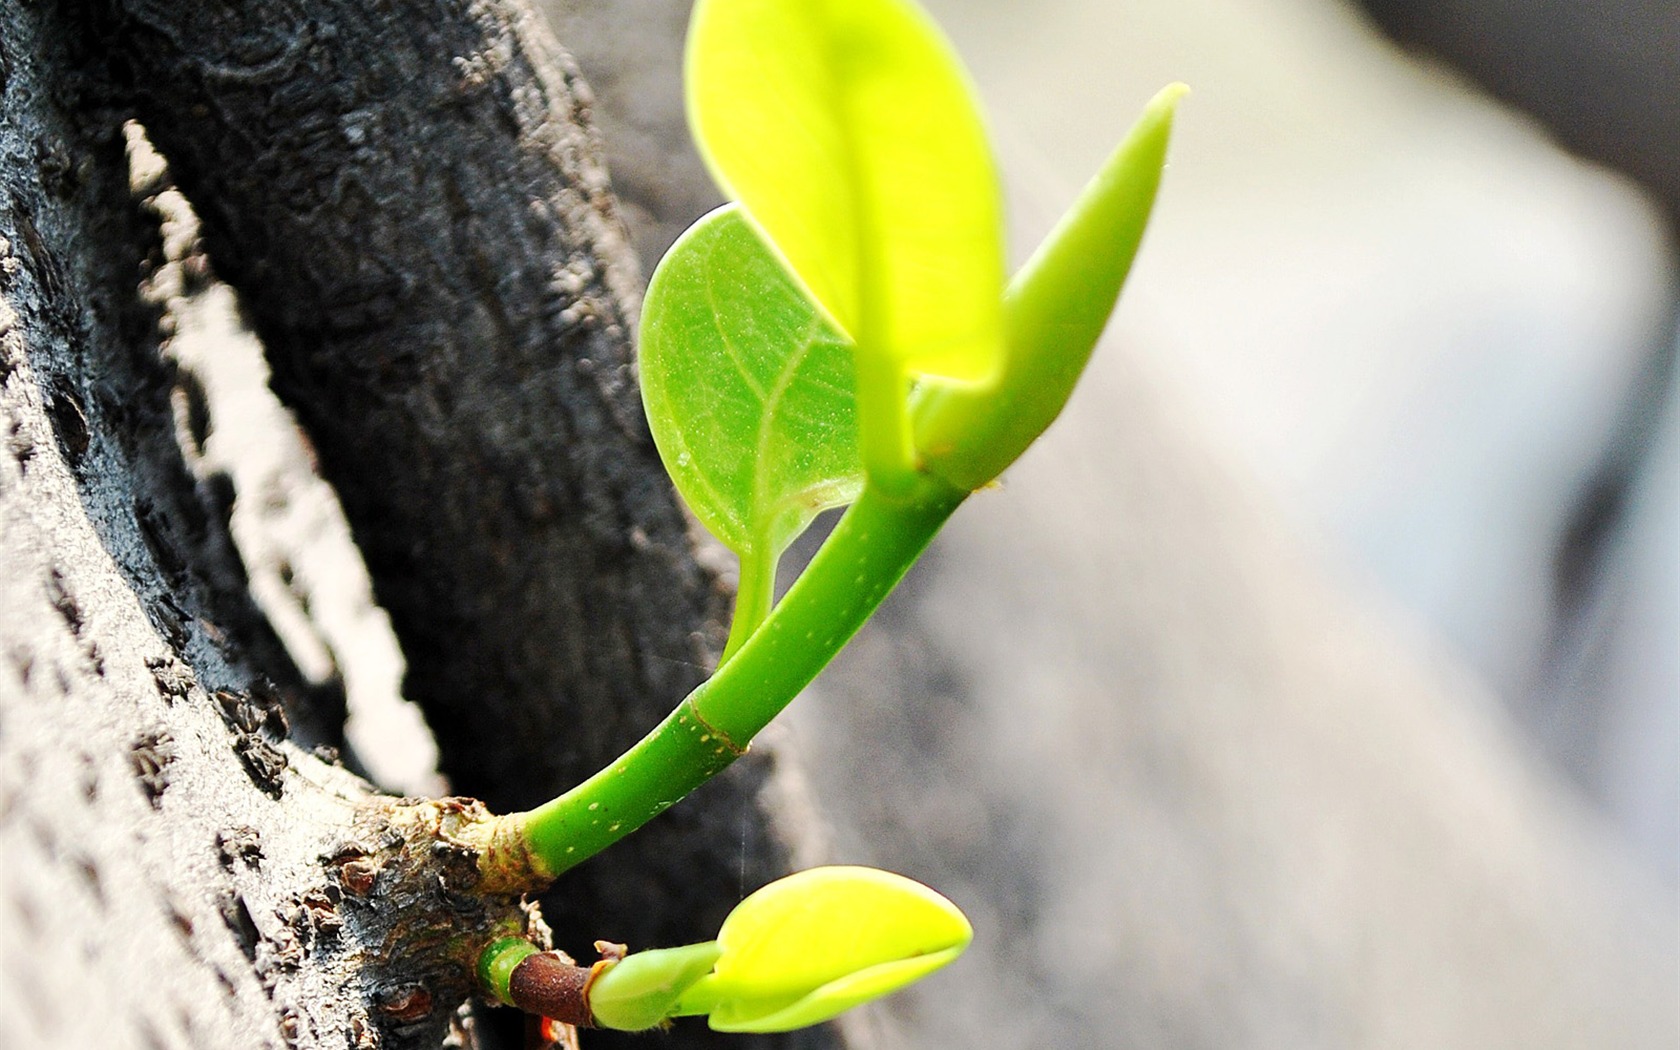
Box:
[0,0,832,1050]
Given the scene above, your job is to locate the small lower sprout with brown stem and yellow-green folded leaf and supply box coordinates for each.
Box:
[482,867,974,1032]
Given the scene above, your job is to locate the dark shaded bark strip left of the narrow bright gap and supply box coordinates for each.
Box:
[3,10,343,746]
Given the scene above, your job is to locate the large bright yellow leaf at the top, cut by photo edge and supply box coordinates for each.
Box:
[687,0,1003,389]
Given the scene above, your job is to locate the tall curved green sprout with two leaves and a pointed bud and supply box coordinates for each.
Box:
[480,0,1184,1030]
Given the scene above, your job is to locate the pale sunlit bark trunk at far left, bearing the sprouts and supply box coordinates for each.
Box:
[0,5,541,1050]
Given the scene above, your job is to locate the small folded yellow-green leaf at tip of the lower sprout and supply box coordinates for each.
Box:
[677,867,974,1032]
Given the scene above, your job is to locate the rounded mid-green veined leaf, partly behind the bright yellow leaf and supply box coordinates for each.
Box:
[642,205,862,571]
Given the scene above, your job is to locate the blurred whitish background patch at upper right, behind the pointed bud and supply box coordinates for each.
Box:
[931,0,1680,882]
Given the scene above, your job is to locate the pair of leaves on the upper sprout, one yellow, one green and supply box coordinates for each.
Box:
[642,0,1003,647]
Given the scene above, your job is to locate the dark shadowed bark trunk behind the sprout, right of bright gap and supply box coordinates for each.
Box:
[63,2,826,1042]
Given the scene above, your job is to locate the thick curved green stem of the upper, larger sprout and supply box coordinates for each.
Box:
[503,475,968,877]
